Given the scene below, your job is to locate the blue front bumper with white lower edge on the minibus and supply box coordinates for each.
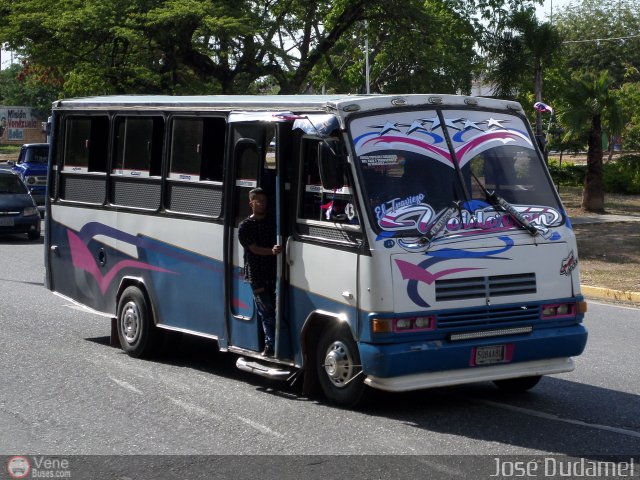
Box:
[360,325,587,392]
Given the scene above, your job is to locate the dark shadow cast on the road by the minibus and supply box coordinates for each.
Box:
[88,335,640,460]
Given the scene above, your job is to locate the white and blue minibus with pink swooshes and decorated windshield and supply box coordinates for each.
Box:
[45,95,587,406]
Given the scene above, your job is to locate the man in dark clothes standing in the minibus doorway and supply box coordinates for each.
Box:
[238,188,282,357]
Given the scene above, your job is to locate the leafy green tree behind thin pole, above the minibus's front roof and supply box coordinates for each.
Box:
[312,0,481,93]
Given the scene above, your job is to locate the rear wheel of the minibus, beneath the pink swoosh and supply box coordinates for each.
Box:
[116,287,160,358]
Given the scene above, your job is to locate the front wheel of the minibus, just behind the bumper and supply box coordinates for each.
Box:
[316,326,365,407]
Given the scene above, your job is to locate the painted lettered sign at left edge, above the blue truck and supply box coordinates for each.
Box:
[0,105,47,145]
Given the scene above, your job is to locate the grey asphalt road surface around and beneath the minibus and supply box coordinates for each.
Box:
[0,231,640,479]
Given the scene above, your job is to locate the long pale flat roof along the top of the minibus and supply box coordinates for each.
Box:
[53,94,522,118]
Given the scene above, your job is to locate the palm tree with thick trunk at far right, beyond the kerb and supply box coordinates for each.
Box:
[560,71,623,212]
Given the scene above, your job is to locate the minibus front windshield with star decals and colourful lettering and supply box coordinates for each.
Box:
[350,110,561,236]
